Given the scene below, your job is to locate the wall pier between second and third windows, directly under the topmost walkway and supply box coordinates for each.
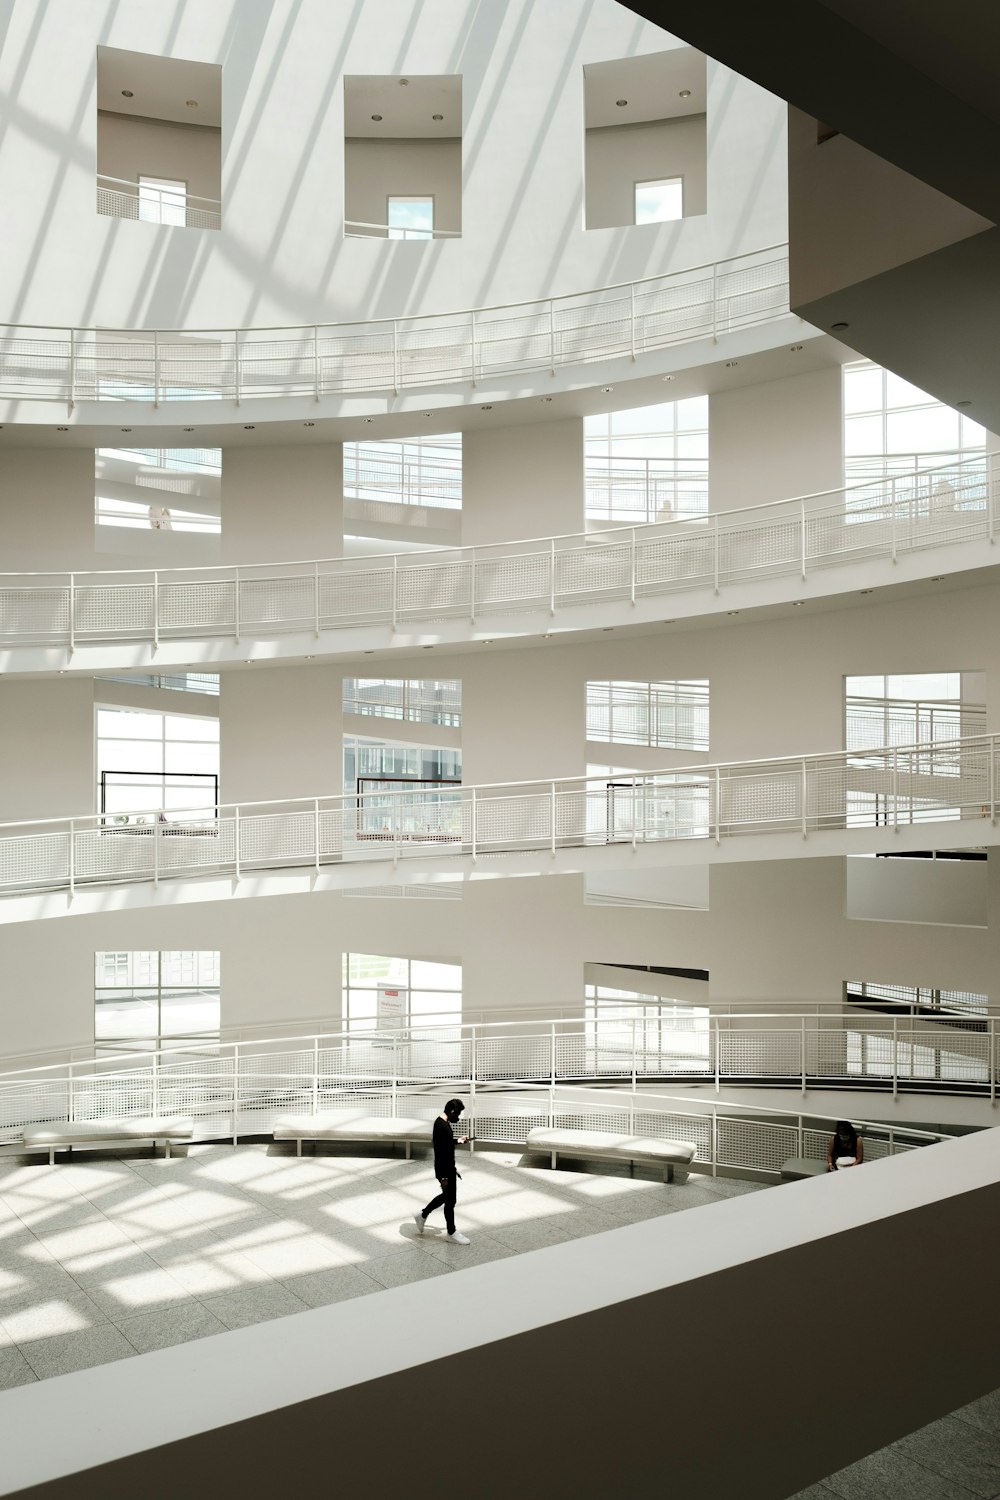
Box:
[462,417,583,546]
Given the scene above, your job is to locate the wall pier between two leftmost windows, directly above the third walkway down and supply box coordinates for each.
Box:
[219,665,343,803]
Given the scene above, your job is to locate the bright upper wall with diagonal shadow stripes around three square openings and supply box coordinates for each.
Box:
[0,0,786,329]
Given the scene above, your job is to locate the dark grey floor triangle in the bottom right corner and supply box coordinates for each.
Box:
[792,1391,1000,1500]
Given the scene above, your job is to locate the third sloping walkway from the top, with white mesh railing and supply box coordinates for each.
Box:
[0,735,1000,923]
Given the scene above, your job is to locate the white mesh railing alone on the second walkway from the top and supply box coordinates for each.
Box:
[0,461,1000,650]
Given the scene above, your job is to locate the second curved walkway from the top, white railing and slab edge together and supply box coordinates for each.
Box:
[0,456,1000,671]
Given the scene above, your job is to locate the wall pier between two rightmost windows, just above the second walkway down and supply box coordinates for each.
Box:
[709,365,844,510]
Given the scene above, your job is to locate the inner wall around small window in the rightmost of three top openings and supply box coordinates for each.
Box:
[585,114,708,230]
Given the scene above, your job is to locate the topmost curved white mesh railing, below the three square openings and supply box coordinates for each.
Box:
[0,243,789,407]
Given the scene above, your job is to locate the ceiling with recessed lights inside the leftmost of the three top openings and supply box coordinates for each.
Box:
[97,47,222,129]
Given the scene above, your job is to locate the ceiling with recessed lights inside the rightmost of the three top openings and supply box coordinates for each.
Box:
[583,47,708,131]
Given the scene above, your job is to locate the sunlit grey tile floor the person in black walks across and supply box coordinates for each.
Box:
[0,1143,757,1389]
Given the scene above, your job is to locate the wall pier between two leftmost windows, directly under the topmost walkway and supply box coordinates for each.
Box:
[222,443,343,563]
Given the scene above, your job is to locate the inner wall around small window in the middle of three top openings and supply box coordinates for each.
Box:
[343,137,462,230]
